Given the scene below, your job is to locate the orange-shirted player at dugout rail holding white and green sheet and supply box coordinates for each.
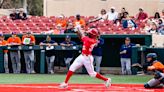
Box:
[22,32,35,73]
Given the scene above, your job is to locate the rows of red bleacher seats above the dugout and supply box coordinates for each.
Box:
[0,16,153,34]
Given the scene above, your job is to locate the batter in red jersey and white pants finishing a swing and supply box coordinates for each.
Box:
[59,27,111,88]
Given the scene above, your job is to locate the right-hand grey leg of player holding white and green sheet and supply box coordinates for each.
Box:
[29,50,35,73]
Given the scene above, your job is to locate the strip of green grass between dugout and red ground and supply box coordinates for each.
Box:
[0,74,153,84]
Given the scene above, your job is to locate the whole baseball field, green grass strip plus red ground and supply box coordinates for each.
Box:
[0,74,164,92]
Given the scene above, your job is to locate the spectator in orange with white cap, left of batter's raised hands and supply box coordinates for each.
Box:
[55,15,67,28]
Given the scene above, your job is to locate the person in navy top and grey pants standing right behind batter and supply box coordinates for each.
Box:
[92,38,104,73]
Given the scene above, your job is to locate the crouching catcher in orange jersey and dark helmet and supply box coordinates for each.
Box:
[143,53,164,88]
